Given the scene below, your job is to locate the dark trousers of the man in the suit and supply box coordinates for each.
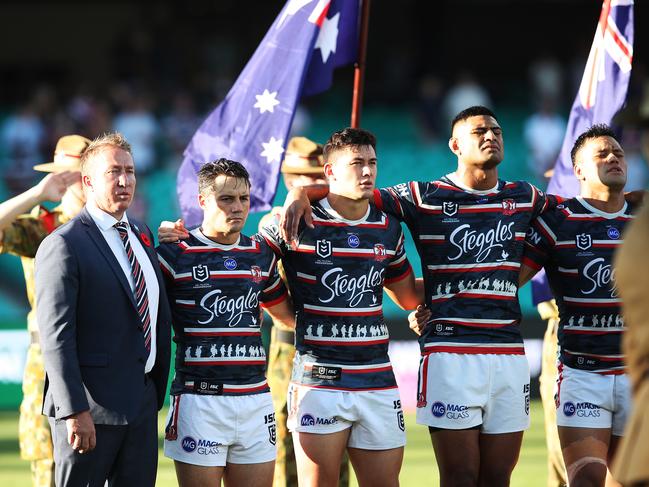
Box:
[50,379,158,487]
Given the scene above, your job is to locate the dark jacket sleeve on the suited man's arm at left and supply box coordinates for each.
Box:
[35,232,89,418]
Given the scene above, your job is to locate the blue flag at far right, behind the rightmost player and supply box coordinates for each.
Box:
[532,0,633,303]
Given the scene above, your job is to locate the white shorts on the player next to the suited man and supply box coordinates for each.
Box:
[164,392,277,467]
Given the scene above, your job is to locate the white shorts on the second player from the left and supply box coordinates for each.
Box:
[287,383,406,450]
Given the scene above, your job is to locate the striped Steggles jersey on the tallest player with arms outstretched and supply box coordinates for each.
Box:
[374,175,556,355]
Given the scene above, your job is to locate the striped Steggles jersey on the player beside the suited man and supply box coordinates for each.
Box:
[157,228,287,395]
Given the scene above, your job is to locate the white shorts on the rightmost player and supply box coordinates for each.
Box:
[555,365,631,436]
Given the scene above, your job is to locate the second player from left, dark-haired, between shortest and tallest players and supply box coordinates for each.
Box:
[262,128,423,486]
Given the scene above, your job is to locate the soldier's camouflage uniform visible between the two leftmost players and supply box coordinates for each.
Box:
[259,211,349,487]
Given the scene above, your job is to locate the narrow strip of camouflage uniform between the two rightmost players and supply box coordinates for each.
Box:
[537,299,568,487]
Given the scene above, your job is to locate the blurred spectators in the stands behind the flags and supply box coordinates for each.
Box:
[0,56,649,214]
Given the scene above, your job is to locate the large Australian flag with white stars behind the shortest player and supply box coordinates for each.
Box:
[178,0,360,228]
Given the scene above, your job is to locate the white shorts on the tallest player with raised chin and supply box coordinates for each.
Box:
[417,352,530,434]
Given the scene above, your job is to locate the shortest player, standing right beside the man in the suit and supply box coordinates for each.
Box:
[158,159,294,487]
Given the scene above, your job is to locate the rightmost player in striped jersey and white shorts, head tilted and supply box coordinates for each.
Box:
[521,125,634,486]
